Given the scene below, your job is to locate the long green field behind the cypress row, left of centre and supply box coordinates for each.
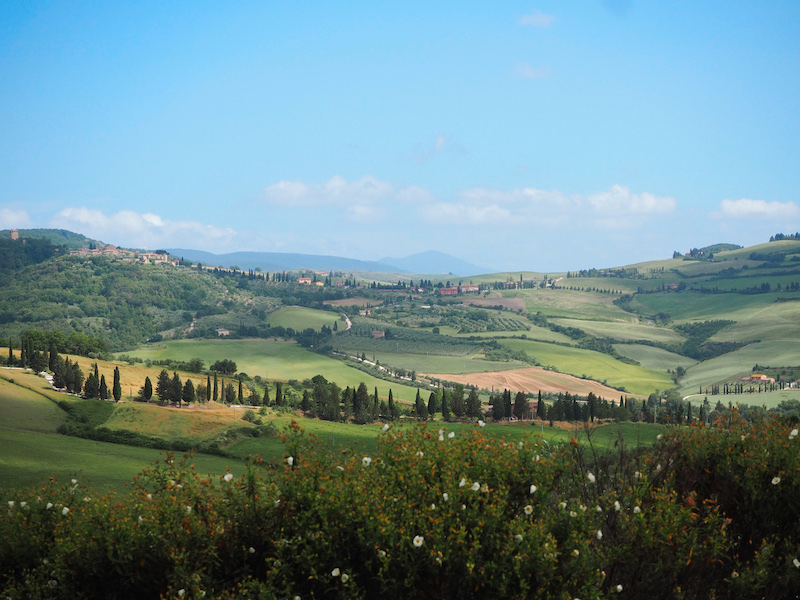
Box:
[122,339,417,402]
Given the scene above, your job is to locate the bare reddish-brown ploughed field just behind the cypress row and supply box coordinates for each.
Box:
[421,367,630,398]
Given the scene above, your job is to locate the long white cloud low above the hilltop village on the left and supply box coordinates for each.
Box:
[50,207,236,249]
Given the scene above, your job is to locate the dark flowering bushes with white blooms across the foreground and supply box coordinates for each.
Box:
[0,420,800,600]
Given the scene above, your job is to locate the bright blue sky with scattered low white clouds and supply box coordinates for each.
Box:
[0,0,800,272]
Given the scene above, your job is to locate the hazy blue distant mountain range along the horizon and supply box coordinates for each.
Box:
[166,248,486,276]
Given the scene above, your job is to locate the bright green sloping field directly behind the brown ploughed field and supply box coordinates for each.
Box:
[502,340,674,395]
